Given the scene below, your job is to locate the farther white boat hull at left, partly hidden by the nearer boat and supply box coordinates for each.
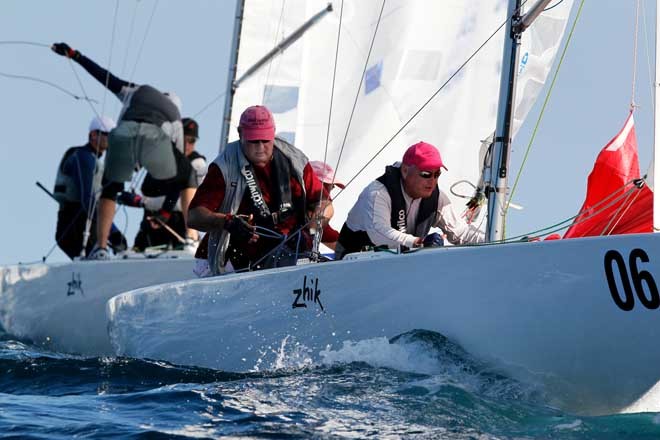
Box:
[0,252,194,355]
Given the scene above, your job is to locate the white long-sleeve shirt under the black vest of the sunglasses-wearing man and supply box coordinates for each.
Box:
[346,180,484,248]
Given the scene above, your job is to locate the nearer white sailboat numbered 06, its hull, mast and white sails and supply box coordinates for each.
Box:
[107,0,660,414]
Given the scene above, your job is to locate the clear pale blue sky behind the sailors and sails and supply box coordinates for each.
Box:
[0,0,655,265]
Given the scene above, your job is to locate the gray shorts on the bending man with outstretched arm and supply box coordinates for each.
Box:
[104,121,177,182]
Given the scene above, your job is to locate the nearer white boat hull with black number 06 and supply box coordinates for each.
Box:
[108,235,660,413]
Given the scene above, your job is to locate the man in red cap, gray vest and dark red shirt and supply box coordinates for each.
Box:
[188,105,332,275]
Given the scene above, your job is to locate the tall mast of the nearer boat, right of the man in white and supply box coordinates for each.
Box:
[485,0,551,242]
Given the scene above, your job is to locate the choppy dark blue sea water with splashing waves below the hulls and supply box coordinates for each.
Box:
[0,331,660,439]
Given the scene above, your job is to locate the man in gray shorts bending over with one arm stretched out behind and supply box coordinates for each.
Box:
[51,43,190,259]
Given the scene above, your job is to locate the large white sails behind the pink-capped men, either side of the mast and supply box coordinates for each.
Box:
[229,0,572,227]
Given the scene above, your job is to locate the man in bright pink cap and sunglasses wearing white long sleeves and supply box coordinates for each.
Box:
[336,142,484,258]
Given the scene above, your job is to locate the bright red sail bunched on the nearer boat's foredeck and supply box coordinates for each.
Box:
[564,113,653,238]
